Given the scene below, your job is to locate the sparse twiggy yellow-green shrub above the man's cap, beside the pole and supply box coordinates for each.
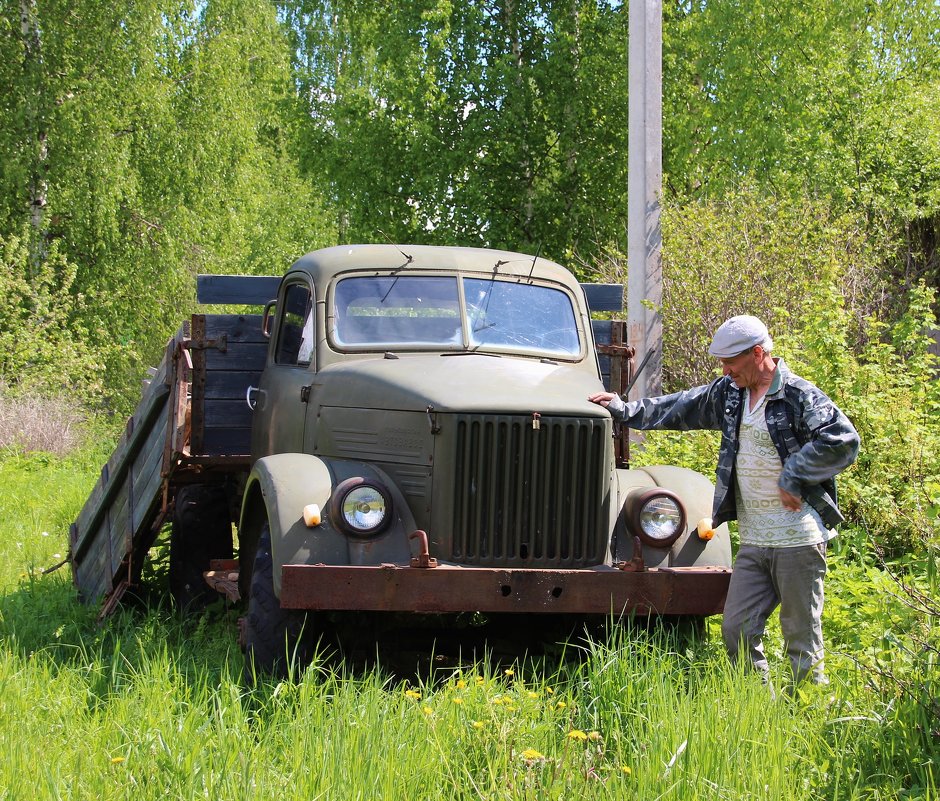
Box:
[662,187,892,389]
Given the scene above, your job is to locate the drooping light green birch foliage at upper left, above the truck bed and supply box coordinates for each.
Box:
[0,0,338,411]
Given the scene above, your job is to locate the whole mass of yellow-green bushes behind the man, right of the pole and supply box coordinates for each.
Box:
[634,190,940,556]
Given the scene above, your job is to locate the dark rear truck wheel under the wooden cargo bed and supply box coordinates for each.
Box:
[170,484,232,612]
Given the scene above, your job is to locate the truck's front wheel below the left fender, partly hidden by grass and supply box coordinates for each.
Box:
[244,523,314,686]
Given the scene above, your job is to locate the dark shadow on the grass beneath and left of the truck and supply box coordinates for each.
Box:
[0,571,720,693]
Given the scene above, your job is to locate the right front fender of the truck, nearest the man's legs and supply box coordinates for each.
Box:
[617,465,731,567]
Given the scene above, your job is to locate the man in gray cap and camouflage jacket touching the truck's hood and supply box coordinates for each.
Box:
[590,315,859,685]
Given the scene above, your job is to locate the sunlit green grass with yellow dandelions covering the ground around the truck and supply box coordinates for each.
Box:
[0,446,940,801]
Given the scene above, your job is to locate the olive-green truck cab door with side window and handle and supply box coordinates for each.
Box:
[251,276,316,459]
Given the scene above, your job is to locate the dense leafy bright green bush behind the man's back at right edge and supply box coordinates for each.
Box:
[787,286,940,555]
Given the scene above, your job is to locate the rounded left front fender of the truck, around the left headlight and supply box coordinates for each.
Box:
[239,453,417,597]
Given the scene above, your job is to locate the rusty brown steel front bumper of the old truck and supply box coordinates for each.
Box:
[281,565,731,615]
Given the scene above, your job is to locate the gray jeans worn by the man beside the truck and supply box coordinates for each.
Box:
[721,542,826,684]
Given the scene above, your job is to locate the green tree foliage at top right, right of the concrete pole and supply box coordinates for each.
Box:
[663,0,940,219]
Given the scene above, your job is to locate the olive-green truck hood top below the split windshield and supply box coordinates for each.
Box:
[313,353,608,417]
